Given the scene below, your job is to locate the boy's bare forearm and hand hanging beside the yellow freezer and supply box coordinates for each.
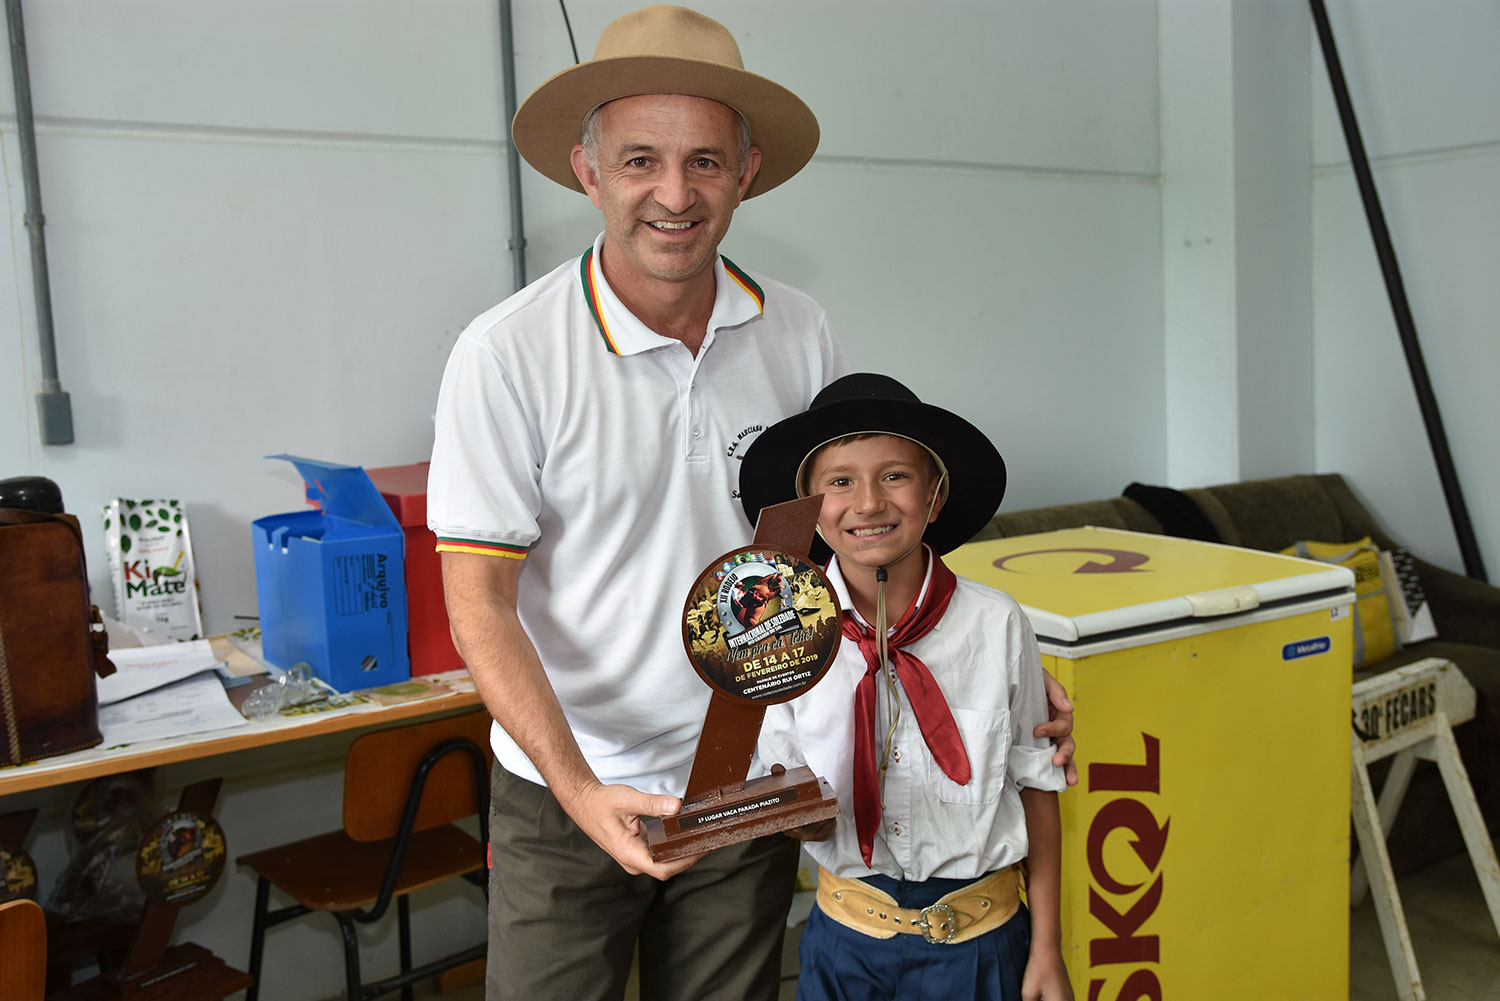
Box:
[1020,786,1073,1001]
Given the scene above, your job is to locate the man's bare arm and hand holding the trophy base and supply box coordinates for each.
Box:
[443,552,699,879]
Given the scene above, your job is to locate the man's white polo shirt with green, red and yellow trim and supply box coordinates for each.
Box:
[428,234,845,795]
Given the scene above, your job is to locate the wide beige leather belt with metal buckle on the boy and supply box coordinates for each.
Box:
[818,866,1020,945]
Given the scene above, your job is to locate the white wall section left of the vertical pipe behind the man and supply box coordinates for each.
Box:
[0,0,512,1001]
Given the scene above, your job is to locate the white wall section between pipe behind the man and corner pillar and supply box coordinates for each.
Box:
[516,0,1166,509]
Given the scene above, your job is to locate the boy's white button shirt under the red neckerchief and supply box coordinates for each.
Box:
[759,558,1067,881]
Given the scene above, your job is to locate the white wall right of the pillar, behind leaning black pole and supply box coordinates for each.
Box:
[1313,0,1500,581]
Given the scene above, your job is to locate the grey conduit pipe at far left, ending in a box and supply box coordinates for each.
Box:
[5,0,74,444]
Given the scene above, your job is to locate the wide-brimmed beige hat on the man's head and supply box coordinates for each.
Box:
[510,5,818,198]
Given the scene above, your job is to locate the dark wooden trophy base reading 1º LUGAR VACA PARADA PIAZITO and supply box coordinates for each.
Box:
[642,765,839,861]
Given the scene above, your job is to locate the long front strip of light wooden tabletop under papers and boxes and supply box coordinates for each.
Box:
[0,681,480,797]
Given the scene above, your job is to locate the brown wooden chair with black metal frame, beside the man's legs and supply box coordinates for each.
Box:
[239,711,489,1001]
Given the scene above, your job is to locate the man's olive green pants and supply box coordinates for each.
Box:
[485,764,797,1001]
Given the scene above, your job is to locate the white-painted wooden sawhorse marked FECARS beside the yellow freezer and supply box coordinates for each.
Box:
[1349,657,1500,1001]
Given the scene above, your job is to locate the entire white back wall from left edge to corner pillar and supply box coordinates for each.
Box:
[0,0,1164,1001]
